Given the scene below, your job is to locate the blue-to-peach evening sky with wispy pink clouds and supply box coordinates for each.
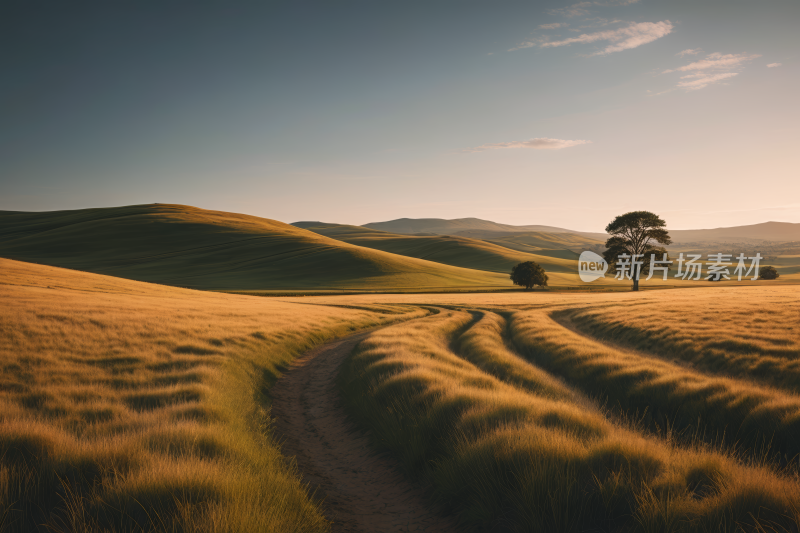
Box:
[0,0,800,231]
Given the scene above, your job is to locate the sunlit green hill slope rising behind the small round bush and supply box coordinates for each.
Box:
[293,222,578,273]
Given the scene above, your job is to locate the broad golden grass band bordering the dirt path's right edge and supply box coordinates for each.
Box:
[340,311,800,531]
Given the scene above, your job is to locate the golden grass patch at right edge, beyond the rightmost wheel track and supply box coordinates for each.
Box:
[570,296,800,392]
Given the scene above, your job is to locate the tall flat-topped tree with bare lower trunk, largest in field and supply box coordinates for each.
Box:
[603,211,672,291]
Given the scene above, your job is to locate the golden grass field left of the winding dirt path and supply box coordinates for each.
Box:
[0,259,424,532]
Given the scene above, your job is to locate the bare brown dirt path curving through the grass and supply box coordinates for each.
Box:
[272,326,456,533]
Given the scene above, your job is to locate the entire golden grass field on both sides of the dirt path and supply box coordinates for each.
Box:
[0,260,800,533]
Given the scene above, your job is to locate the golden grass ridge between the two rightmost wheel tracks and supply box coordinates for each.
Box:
[511,311,800,458]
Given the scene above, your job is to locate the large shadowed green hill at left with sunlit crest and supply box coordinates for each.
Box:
[0,204,511,290]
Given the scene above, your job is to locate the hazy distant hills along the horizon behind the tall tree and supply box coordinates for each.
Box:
[364,218,800,243]
